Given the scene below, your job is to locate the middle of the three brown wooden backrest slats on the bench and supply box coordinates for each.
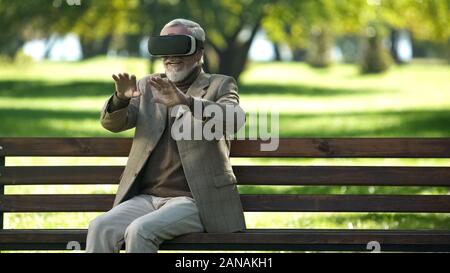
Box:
[0,166,450,187]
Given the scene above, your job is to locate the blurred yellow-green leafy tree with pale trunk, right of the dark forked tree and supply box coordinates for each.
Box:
[263,0,367,67]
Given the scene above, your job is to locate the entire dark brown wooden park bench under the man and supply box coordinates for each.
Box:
[0,138,450,251]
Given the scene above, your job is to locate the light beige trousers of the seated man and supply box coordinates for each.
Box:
[86,194,204,253]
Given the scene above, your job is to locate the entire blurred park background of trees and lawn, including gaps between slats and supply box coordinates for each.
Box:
[0,0,450,251]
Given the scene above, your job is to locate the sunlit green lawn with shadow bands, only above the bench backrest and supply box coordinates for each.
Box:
[0,58,450,137]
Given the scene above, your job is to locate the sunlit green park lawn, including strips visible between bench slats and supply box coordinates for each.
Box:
[0,58,450,249]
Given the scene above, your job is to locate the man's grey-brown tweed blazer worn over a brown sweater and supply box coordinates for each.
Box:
[100,72,246,232]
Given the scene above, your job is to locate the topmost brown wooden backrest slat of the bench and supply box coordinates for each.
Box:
[0,137,450,158]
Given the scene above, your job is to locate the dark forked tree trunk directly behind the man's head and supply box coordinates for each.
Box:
[183,0,276,79]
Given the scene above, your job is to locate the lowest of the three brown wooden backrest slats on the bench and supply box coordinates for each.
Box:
[0,194,450,213]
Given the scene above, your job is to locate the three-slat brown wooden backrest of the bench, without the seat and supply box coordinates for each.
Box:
[0,138,450,228]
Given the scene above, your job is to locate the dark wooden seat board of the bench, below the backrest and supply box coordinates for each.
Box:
[0,229,450,251]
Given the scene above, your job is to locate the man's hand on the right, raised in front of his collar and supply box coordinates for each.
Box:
[148,76,188,107]
